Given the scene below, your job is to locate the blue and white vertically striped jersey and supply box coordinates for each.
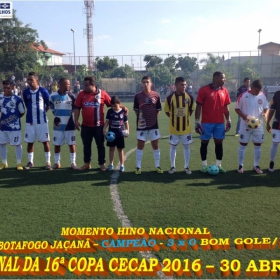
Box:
[23,87,50,124]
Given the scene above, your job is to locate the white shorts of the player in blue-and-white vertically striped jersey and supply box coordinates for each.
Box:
[24,123,50,143]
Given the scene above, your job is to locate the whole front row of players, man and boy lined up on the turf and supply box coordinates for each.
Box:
[0,72,280,175]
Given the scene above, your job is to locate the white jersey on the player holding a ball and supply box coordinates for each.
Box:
[235,91,269,129]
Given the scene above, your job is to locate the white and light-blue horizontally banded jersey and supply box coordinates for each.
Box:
[50,92,75,131]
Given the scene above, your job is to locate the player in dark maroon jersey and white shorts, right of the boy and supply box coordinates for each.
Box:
[133,76,163,175]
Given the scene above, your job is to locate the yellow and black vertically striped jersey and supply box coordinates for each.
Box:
[164,92,194,135]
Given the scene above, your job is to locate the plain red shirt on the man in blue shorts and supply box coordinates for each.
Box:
[196,84,231,123]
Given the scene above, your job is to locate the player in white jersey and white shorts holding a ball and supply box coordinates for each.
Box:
[235,80,268,174]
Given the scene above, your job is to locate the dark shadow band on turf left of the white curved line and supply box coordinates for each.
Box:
[0,167,111,188]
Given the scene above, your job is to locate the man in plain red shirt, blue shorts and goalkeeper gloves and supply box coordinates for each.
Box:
[195,72,231,173]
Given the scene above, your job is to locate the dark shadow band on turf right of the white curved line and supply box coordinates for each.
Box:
[118,170,280,190]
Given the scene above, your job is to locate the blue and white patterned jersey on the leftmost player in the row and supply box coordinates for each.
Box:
[0,94,24,131]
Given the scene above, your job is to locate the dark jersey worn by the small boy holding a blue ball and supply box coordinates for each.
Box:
[106,109,127,137]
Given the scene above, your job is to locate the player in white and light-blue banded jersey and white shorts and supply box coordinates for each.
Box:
[50,78,78,169]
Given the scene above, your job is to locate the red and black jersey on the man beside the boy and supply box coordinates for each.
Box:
[75,89,111,127]
